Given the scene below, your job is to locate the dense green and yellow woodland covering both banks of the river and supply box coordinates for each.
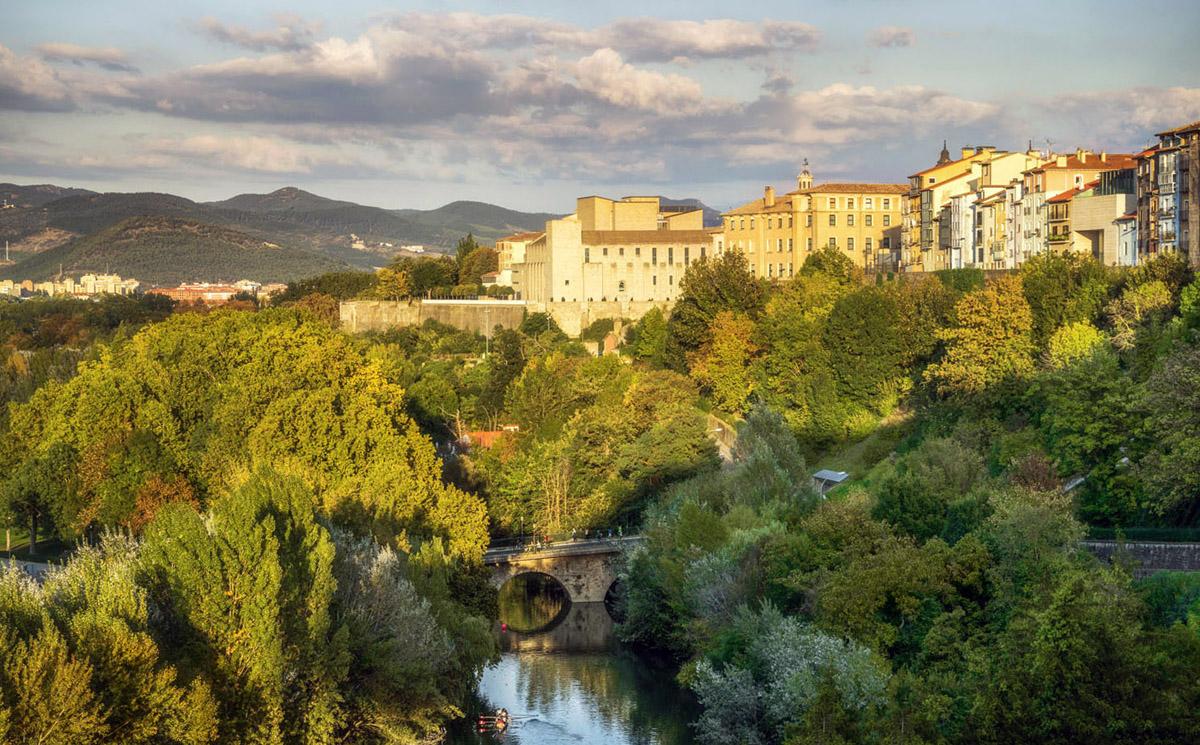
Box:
[0,242,1200,745]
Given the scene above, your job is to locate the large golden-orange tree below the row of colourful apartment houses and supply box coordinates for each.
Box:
[925,277,1033,395]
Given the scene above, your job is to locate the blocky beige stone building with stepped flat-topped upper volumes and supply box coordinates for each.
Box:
[511,197,722,307]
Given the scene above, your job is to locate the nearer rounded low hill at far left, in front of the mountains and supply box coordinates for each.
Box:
[0,216,349,286]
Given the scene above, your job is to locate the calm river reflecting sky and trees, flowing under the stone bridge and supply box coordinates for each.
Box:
[446,575,698,745]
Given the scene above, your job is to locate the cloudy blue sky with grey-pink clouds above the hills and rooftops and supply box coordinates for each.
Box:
[0,0,1200,212]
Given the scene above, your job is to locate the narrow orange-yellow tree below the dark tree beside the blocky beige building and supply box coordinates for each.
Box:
[690,311,757,414]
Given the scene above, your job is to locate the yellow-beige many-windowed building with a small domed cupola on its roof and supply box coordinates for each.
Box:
[722,168,908,278]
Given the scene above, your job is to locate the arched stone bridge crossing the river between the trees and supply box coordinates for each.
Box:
[484,536,642,603]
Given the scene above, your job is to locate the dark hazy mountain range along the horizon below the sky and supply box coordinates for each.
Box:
[0,184,720,286]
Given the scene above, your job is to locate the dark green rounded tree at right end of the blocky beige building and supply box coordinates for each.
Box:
[666,251,767,372]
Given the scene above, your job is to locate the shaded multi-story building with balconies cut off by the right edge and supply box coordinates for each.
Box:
[1138,121,1200,266]
